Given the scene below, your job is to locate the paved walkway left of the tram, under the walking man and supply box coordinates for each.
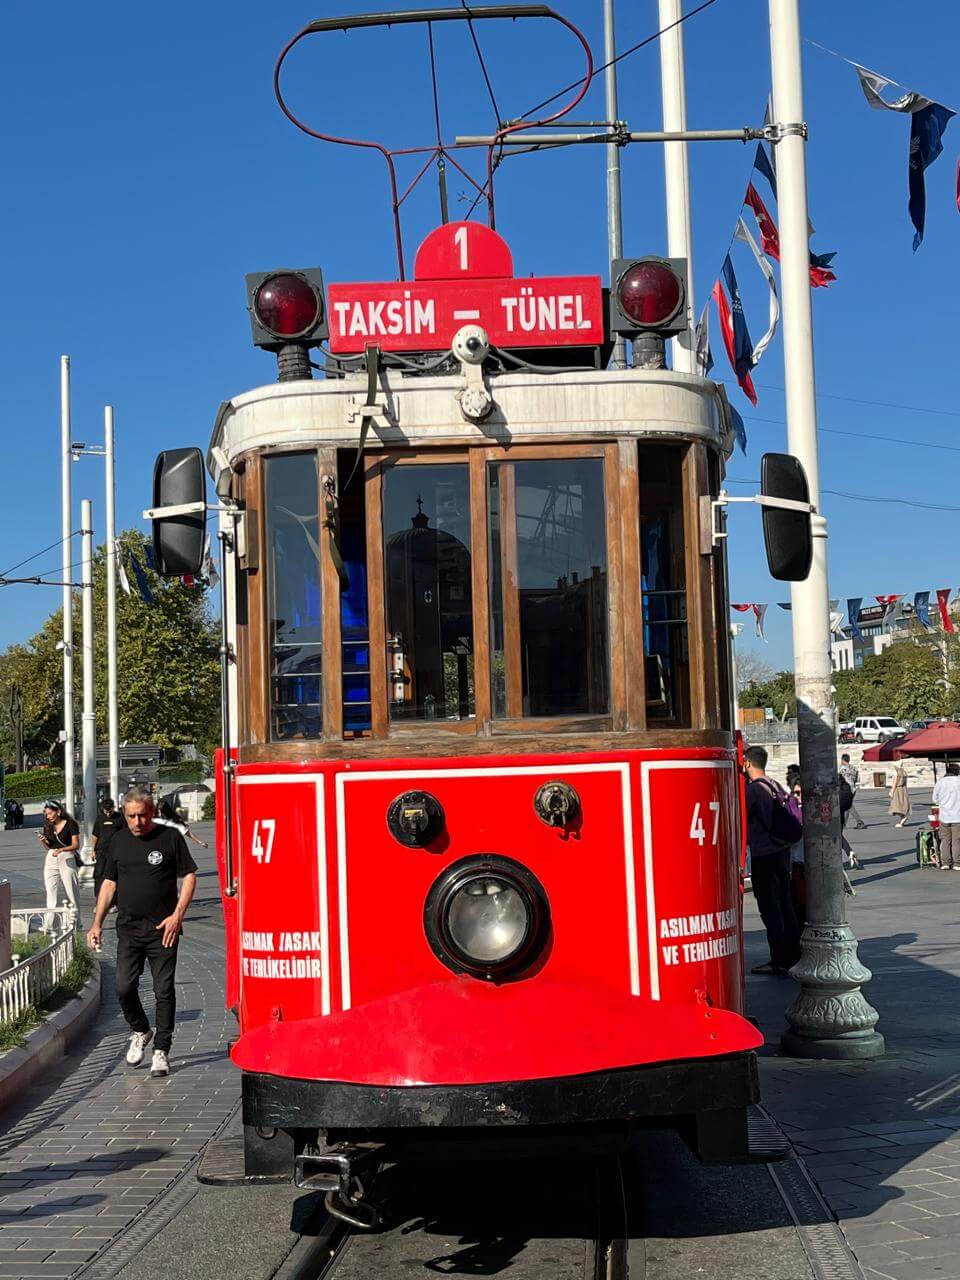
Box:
[0,934,238,1280]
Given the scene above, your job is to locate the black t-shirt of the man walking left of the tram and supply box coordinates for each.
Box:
[104,826,197,924]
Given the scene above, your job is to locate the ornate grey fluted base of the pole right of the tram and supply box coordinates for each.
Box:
[781,924,884,1061]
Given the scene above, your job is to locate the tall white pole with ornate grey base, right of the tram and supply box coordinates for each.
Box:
[769,0,883,1059]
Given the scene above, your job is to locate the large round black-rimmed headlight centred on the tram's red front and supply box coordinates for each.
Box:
[424,854,549,978]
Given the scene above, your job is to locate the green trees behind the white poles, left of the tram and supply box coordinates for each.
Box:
[0,530,220,768]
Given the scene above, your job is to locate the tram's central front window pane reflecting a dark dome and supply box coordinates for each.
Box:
[383,463,475,723]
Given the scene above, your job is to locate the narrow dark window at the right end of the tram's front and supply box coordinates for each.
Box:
[639,444,691,727]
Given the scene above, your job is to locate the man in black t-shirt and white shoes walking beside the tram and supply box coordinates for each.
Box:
[87,788,197,1076]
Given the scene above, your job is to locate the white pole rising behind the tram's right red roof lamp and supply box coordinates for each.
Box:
[659,0,696,374]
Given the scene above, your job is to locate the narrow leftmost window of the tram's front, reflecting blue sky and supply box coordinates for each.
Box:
[264,453,323,741]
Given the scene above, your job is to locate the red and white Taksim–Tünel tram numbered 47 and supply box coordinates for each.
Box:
[151,12,809,1215]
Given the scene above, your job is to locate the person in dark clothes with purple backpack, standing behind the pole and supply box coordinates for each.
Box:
[744,746,803,975]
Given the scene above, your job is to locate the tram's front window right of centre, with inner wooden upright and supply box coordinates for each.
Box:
[488,458,609,718]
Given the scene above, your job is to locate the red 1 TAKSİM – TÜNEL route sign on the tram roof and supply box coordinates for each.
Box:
[326,223,604,355]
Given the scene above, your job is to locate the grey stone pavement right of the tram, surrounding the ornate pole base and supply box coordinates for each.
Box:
[746,791,960,1280]
